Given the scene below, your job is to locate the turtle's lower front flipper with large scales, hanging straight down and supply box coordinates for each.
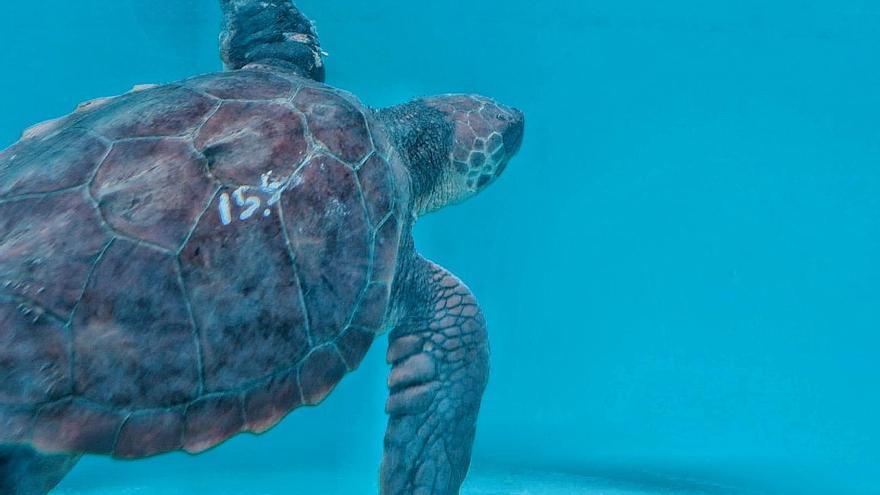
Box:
[381,258,489,495]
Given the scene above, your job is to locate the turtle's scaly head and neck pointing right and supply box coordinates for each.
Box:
[379,95,525,215]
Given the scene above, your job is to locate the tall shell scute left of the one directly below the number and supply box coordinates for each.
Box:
[72,239,199,408]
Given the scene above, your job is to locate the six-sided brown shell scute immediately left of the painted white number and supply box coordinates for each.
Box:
[91,139,215,251]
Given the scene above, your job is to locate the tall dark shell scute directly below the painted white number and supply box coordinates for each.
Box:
[180,191,309,391]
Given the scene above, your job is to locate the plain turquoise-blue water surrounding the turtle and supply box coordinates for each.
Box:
[0,0,880,495]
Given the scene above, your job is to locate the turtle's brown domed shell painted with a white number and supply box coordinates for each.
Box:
[0,70,409,458]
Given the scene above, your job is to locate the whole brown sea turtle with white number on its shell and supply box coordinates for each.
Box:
[0,0,524,495]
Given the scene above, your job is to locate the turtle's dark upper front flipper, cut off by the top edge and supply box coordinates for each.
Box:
[220,0,324,82]
